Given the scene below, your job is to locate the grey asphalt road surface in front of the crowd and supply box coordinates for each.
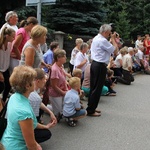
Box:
[41,74,150,150]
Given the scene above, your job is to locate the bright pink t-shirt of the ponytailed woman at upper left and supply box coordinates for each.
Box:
[12,28,30,53]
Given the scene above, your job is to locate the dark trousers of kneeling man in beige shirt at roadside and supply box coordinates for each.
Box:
[117,69,134,85]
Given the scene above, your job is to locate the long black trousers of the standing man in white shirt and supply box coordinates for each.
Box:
[87,61,107,114]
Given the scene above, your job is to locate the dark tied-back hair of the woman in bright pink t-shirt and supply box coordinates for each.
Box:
[19,17,38,28]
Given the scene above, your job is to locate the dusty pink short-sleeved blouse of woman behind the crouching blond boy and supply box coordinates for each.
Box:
[49,63,68,97]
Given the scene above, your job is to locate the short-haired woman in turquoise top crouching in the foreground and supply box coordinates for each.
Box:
[1,66,55,150]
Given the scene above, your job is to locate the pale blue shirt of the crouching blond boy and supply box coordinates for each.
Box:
[63,89,81,117]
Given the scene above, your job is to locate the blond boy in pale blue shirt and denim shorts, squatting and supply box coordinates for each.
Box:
[63,77,87,127]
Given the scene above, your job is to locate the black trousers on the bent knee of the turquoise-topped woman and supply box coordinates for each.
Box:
[34,129,52,143]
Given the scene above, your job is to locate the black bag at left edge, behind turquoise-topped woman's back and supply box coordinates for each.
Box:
[0,102,8,139]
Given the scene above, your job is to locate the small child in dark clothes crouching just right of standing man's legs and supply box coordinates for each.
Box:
[105,69,116,96]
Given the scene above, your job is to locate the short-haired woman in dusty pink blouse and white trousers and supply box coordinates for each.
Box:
[49,49,68,121]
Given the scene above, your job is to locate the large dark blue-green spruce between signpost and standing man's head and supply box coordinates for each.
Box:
[43,0,106,35]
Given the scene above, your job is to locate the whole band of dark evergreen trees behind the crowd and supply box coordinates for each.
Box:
[0,0,150,39]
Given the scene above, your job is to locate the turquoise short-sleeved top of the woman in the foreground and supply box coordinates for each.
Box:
[1,93,37,150]
